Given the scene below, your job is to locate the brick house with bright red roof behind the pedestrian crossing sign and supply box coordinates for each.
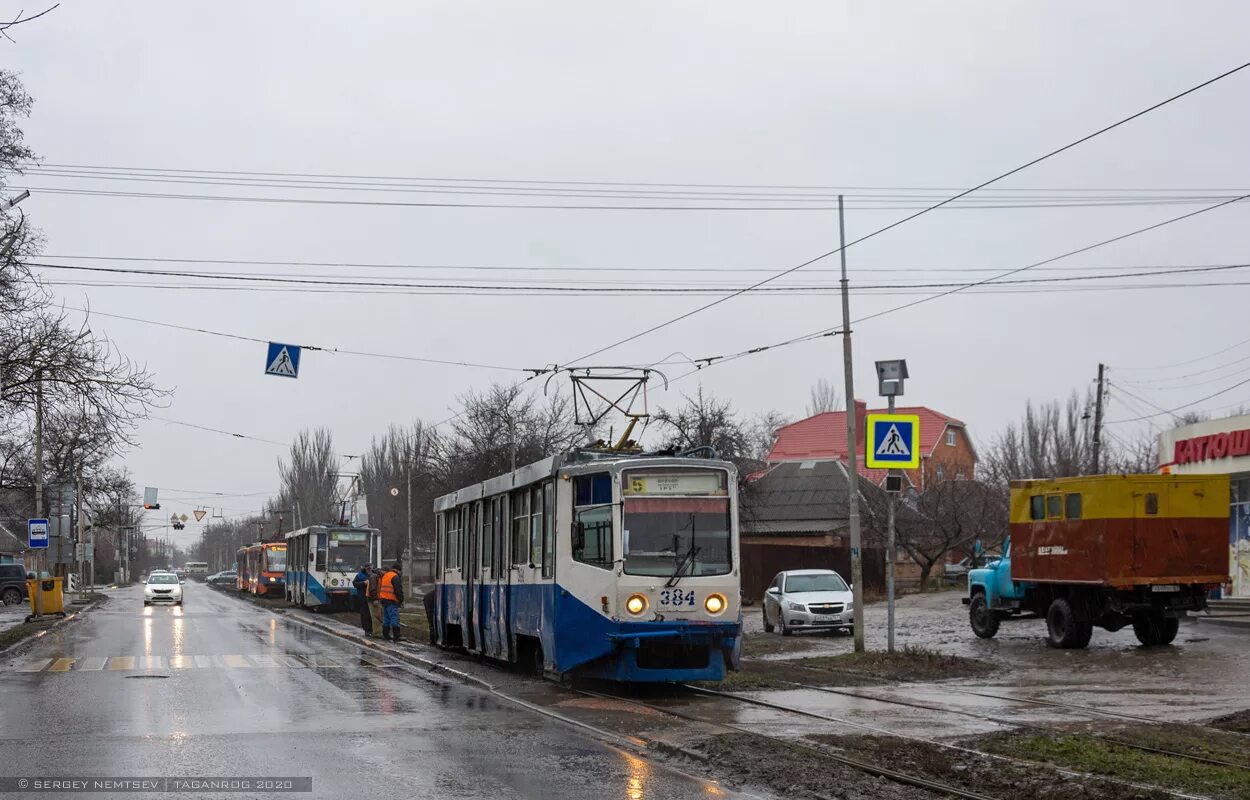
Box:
[768,400,976,491]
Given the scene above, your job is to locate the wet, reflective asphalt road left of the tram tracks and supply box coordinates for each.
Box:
[0,583,729,800]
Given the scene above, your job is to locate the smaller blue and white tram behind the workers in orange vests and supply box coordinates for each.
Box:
[286,525,383,609]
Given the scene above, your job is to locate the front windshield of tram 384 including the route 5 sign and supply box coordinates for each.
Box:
[621,470,733,578]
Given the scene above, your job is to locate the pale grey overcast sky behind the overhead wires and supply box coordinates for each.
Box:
[9,0,1250,543]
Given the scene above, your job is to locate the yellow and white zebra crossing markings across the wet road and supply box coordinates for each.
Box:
[9,653,394,673]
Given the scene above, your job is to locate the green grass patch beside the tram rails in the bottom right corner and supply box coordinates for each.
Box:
[978,734,1250,800]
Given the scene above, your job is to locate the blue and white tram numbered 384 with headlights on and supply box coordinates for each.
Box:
[434,450,741,681]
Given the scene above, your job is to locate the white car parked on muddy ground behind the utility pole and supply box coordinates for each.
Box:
[764,570,855,636]
